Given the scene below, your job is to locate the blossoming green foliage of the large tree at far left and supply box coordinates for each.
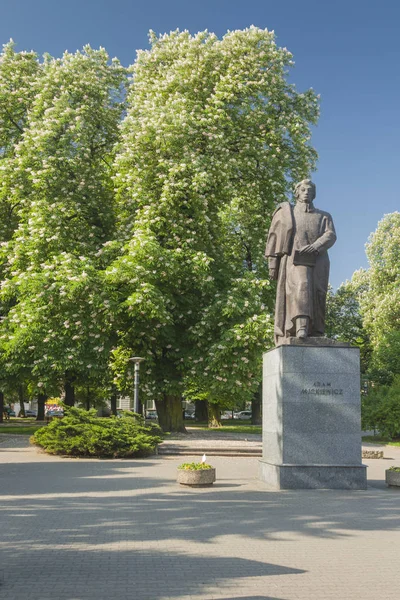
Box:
[0,46,126,393]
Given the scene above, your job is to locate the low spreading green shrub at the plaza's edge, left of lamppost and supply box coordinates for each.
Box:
[31,405,162,458]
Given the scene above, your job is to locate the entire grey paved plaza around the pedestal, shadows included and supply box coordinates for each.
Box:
[0,436,400,600]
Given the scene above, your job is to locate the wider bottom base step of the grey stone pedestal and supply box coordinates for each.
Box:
[259,460,367,490]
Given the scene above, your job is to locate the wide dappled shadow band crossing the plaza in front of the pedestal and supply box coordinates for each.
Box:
[0,457,399,545]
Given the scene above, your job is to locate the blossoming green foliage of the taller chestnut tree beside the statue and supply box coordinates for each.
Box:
[108,27,318,429]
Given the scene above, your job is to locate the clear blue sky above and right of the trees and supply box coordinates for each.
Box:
[0,0,400,287]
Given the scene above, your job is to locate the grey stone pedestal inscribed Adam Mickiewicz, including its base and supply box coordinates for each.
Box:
[259,345,367,490]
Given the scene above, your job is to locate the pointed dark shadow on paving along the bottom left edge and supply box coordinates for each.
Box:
[1,549,306,600]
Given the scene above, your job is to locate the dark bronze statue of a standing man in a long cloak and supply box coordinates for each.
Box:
[265,179,336,346]
